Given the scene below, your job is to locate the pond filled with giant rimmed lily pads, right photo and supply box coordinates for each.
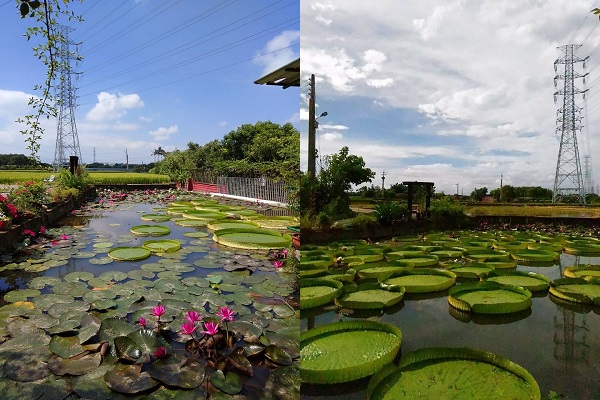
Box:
[300,231,600,400]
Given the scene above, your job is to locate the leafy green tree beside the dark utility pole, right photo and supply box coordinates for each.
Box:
[300,146,375,217]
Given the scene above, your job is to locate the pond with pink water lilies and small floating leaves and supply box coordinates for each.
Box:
[0,191,300,399]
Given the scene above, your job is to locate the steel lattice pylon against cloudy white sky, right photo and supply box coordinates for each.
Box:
[552,44,587,204]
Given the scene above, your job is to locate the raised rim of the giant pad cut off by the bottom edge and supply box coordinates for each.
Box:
[367,347,542,400]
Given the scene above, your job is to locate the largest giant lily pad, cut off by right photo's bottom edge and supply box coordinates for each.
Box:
[368,348,541,400]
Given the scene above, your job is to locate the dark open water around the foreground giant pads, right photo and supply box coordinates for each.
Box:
[301,254,600,400]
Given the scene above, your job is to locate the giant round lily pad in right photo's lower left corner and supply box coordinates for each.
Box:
[300,321,402,384]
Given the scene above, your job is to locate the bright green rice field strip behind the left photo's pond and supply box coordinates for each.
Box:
[0,170,171,185]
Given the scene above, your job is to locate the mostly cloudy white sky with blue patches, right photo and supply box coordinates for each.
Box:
[300,0,600,195]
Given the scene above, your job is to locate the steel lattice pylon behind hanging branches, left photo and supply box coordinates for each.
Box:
[53,25,81,171]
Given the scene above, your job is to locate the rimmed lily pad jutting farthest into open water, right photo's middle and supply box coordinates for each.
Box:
[448,282,531,314]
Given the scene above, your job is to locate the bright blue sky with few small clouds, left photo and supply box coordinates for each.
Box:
[0,0,300,163]
